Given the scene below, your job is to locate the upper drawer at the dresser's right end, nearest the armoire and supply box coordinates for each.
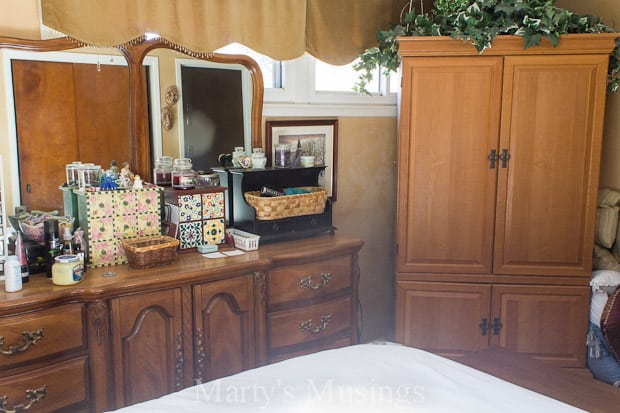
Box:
[267,255,351,305]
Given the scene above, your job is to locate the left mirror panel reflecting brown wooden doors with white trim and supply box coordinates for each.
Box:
[3,51,130,211]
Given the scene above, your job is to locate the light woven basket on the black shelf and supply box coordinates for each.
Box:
[243,186,327,220]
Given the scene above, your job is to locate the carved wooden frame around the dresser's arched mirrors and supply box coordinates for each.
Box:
[0,36,264,187]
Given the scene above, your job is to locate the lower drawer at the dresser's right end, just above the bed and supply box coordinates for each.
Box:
[267,297,351,349]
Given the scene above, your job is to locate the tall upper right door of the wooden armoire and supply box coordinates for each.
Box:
[494,55,607,276]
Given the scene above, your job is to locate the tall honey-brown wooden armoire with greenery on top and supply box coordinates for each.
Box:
[395,34,617,368]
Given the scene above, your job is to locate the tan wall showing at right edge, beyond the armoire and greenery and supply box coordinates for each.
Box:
[557,0,620,189]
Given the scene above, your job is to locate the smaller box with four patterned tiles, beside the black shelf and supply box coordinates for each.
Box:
[165,186,226,251]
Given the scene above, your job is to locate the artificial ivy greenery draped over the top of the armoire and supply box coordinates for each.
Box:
[354,0,620,94]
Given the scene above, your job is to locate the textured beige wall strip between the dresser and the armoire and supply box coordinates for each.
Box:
[333,118,398,341]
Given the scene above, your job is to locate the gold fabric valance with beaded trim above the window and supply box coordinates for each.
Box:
[41,0,407,64]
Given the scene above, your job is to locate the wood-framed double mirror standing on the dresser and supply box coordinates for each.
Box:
[0,37,263,211]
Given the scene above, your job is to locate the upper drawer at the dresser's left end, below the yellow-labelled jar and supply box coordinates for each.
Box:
[0,304,86,369]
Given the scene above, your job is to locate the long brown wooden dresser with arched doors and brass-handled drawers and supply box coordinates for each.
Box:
[0,235,363,412]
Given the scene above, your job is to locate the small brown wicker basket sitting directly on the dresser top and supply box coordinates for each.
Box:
[123,235,179,268]
